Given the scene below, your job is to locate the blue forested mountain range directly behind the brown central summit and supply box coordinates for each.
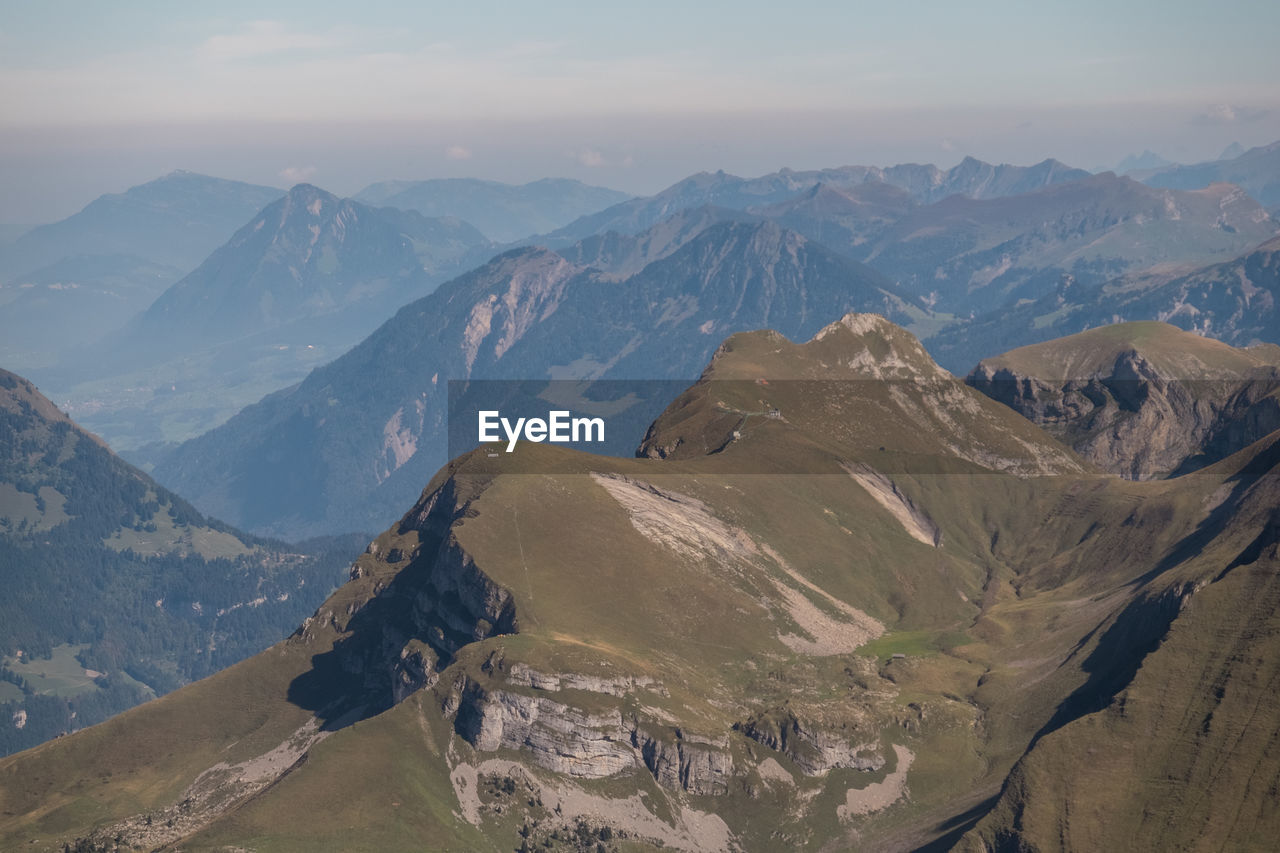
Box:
[137,174,1276,535]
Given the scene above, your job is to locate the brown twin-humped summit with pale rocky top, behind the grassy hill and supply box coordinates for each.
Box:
[639,313,1084,476]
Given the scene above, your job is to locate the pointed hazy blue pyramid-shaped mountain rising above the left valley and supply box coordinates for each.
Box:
[32,184,492,451]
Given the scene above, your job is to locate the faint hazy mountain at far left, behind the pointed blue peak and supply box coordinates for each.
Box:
[0,172,283,282]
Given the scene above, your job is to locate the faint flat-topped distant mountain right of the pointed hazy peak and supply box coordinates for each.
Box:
[355,178,630,242]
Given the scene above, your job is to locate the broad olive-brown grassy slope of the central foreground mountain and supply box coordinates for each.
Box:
[0,315,1270,850]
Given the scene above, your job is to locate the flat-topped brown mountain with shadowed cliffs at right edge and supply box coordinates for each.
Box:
[966,321,1280,480]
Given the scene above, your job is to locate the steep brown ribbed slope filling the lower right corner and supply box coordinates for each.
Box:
[966,437,1280,849]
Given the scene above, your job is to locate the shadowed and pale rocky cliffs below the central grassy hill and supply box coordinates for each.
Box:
[280,450,886,797]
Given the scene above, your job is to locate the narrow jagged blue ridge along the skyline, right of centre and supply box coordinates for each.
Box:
[539,158,1089,247]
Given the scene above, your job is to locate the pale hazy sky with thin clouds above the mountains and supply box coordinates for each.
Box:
[0,0,1280,223]
